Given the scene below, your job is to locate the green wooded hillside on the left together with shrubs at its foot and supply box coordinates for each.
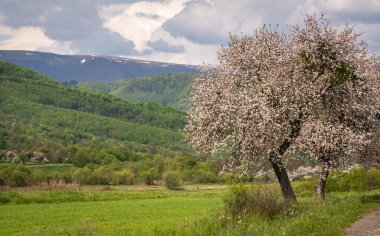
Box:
[0,62,232,186]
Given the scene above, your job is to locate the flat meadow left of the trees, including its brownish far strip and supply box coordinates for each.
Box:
[0,186,225,235]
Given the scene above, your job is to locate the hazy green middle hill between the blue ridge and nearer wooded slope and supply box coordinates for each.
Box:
[78,73,195,111]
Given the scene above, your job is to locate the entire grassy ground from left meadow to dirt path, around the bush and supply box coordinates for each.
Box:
[0,184,380,235]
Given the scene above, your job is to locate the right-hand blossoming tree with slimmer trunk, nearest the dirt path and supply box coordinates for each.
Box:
[291,15,380,199]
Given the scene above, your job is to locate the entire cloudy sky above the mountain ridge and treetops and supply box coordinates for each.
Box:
[0,0,380,64]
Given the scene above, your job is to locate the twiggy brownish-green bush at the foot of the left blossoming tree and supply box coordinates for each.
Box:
[223,183,288,218]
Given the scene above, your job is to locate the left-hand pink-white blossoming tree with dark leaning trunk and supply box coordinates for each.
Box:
[187,27,306,201]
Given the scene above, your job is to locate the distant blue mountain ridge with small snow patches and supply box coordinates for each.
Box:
[0,50,199,82]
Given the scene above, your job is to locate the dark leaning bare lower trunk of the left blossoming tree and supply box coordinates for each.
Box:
[270,160,297,202]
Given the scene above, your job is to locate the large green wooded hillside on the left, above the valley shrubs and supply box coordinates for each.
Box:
[0,62,189,163]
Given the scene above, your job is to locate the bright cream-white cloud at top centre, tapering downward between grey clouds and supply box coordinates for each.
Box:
[99,0,187,52]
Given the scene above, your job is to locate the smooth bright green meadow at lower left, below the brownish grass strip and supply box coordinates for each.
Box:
[0,197,221,235]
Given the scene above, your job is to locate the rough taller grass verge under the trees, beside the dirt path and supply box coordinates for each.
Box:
[156,190,380,236]
